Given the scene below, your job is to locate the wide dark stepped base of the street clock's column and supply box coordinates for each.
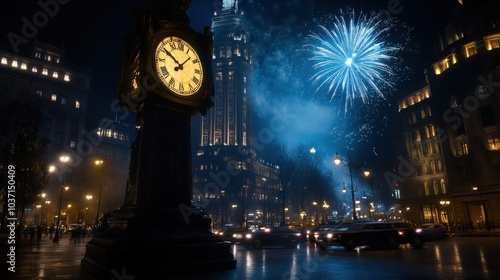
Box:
[81,208,236,279]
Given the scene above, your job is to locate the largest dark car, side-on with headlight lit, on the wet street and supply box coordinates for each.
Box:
[317,221,399,251]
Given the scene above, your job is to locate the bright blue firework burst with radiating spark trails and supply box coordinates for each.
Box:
[306,12,398,113]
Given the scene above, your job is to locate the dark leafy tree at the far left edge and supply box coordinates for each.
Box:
[0,101,49,235]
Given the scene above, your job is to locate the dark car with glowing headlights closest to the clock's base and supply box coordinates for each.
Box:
[240,227,302,249]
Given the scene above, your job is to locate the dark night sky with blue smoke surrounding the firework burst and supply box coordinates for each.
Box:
[0,0,457,182]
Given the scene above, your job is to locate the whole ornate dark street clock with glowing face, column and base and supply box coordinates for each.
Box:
[81,0,236,279]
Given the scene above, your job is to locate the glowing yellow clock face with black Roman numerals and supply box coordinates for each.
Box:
[155,36,204,96]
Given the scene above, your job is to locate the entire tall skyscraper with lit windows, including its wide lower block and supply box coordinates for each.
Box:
[193,0,281,226]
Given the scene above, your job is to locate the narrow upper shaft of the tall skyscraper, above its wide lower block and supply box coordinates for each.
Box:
[200,0,253,149]
